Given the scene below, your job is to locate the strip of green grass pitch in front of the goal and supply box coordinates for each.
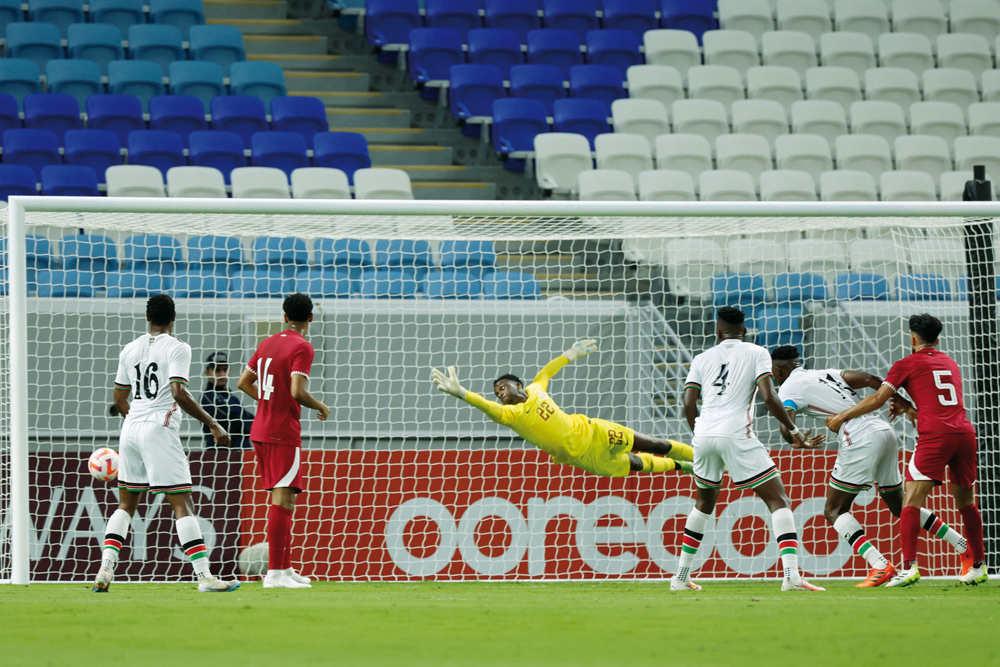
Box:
[0,580,1000,667]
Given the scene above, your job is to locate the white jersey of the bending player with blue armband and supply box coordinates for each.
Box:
[778,368,892,445]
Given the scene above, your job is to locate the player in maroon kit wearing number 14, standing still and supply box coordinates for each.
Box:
[236,294,330,588]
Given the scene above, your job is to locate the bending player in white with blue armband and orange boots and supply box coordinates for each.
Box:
[771,345,968,588]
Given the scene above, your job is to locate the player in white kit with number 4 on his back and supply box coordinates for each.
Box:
[670,307,826,591]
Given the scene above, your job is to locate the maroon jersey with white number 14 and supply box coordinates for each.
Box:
[247,329,314,447]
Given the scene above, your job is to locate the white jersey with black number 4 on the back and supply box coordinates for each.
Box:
[684,338,771,439]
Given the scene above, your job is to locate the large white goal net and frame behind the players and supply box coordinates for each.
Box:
[0,198,1000,582]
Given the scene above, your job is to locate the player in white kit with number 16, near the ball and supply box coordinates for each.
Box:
[94,294,240,593]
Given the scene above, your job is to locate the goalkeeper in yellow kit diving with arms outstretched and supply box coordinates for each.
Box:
[431,340,694,477]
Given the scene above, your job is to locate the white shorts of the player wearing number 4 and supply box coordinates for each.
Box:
[691,436,779,491]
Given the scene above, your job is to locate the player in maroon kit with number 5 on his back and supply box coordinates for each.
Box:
[826,314,988,586]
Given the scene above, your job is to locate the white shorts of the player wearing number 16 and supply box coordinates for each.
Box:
[118,421,191,493]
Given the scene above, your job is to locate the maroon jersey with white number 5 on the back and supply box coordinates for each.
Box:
[885,348,975,438]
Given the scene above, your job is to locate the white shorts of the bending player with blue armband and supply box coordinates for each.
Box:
[830,430,903,494]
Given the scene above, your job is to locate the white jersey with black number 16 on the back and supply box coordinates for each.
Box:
[115,333,191,428]
